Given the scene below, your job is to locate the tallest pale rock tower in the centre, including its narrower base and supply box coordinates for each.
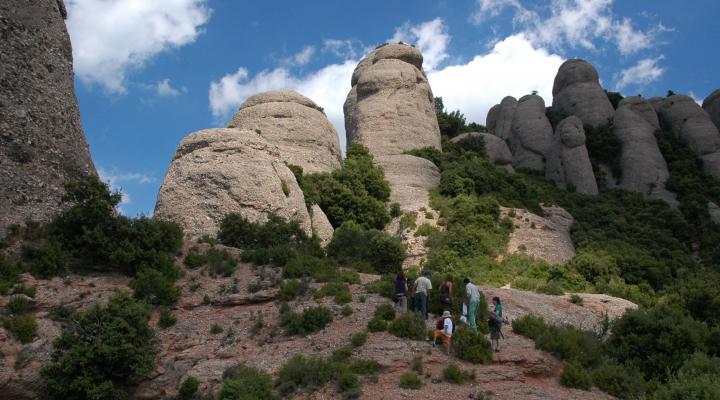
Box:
[344,44,440,210]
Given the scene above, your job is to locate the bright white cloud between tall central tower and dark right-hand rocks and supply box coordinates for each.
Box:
[428,34,563,125]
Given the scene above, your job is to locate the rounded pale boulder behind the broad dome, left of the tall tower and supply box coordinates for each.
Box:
[228,91,341,172]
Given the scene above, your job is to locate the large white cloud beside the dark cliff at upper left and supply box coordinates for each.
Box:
[67,0,211,94]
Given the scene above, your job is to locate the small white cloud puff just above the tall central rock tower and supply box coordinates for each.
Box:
[390,18,450,71]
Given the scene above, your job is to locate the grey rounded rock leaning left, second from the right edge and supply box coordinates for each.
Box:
[659,94,720,178]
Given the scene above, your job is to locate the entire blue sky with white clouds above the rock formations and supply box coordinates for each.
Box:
[66,0,720,216]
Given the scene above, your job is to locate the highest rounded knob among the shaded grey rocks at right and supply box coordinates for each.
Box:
[552,59,615,127]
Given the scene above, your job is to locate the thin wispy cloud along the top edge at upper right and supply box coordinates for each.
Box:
[472,0,668,55]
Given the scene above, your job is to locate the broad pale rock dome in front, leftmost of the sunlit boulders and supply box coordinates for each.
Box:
[155,128,312,238]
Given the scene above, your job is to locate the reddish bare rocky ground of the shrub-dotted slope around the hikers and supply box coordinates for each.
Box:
[0,242,635,399]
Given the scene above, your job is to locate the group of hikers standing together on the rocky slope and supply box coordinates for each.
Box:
[394,270,503,353]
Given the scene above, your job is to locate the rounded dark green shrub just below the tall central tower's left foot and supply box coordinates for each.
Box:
[327,222,405,274]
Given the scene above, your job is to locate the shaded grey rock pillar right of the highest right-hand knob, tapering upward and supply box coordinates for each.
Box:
[613,96,677,205]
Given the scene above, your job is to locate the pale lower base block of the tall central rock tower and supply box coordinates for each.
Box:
[375,154,440,210]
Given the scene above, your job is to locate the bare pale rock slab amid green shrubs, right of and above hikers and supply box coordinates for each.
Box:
[500,206,575,264]
